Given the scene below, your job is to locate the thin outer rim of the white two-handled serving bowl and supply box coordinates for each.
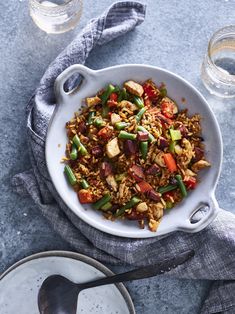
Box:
[46,64,223,238]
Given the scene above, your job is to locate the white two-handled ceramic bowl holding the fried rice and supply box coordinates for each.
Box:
[46,65,222,238]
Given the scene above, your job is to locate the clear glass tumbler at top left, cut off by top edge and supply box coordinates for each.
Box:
[29,0,82,34]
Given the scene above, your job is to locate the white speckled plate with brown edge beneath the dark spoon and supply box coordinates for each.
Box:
[0,251,135,314]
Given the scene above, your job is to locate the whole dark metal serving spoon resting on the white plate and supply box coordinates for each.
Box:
[38,250,194,314]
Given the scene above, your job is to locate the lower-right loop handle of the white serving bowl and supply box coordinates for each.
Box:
[178,194,220,233]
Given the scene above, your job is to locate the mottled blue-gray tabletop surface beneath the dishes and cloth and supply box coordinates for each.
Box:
[0,0,235,314]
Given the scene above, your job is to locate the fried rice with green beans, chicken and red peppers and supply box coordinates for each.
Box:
[63,80,210,232]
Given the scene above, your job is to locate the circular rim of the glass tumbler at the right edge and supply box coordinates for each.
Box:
[207,24,235,82]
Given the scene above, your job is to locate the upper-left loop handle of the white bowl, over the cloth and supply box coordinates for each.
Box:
[54,64,95,102]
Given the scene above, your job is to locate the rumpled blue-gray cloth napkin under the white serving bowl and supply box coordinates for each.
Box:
[13,2,235,313]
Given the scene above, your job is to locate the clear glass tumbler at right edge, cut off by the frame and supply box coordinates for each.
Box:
[201,25,235,98]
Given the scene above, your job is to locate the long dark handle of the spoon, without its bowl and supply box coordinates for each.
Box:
[78,250,194,290]
